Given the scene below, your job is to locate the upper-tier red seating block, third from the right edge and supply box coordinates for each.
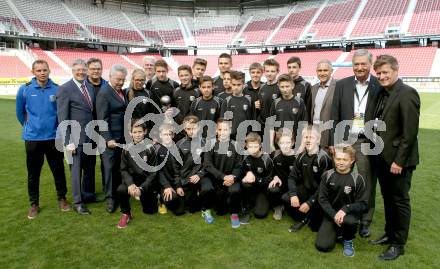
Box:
[309,0,361,40]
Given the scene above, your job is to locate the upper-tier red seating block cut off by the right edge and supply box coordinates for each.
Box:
[408,0,440,35]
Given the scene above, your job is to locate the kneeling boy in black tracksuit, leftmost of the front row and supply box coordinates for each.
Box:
[117,120,159,228]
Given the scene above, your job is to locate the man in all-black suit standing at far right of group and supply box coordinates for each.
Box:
[370,55,420,260]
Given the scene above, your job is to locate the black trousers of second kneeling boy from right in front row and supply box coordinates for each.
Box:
[282,192,324,232]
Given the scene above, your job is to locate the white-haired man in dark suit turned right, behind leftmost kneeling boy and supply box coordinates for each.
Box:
[96,64,128,213]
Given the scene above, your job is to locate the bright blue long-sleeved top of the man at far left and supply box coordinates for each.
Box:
[15,78,58,141]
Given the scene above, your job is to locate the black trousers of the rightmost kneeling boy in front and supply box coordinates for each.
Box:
[315,214,359,252]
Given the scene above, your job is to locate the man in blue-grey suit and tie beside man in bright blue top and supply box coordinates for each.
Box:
[57,60,95,215]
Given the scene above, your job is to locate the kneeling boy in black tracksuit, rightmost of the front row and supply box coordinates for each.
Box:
[315,145,368,257]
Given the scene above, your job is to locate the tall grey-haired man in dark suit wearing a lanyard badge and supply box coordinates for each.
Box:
[330,49,380,237]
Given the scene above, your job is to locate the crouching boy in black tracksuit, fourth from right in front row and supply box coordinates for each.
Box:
[240,132,276,224]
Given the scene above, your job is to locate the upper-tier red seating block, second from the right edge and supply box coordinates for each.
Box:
[351,0,408,37]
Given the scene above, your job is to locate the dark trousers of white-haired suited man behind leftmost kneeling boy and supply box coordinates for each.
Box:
[102,147,122,199]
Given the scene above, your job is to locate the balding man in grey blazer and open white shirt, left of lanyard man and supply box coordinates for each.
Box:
[309,59,336,152]
